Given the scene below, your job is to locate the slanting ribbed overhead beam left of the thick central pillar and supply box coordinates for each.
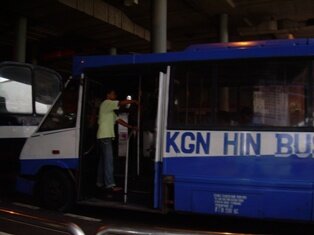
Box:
[59,0,151,42]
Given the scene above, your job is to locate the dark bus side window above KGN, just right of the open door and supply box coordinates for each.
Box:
[170,63,212,128]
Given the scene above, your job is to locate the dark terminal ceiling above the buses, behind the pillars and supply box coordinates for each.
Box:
[0,0,314,70]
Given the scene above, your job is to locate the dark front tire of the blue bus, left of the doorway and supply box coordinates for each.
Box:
[38,170,75,211]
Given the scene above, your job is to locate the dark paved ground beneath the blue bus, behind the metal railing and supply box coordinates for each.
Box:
[0,186,314,235]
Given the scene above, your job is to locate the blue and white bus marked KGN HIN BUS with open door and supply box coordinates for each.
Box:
[17,39,314,221]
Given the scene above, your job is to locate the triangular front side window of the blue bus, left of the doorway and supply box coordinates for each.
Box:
[39,81,78,132]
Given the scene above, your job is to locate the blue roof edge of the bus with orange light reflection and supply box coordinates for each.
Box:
[73,39,314,76]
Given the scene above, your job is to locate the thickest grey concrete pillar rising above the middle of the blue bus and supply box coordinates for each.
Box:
[152,0,167,53]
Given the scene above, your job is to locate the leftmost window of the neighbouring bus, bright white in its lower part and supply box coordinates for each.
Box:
[0,66,33,114]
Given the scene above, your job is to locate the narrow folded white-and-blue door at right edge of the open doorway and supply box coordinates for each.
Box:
[154,66,170,208]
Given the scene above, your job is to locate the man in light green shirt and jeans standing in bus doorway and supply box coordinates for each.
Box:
[97,90,138,192]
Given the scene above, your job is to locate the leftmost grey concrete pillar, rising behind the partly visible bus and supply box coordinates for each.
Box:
[15,17,27,63]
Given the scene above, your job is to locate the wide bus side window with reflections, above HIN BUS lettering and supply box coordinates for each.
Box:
[217,59,310,127]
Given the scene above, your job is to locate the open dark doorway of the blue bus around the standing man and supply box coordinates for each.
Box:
[79,64,160,208]
